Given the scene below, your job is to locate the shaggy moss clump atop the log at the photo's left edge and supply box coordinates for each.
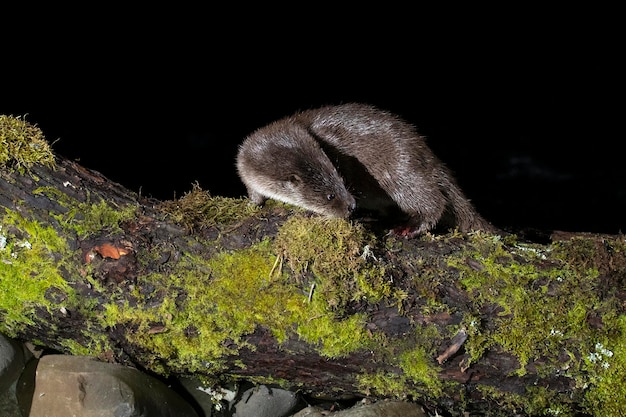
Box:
[0,115,55,174]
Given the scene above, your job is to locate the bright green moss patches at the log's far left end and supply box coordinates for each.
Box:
[0,187,136,356]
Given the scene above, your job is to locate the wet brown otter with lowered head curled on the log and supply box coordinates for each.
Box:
[236,103,496,237]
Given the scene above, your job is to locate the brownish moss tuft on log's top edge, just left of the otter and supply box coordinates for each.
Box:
[159,183,260,230]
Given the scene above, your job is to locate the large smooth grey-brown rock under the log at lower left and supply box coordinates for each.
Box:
[28,355,198,417]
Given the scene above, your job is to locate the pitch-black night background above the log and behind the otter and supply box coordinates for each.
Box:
[0,8,626,233]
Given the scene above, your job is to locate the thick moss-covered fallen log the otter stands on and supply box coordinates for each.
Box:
[0,128,626,416]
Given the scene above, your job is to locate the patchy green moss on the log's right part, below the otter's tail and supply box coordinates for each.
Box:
[449,232,600,375]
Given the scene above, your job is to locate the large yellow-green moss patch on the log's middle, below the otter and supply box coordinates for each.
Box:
[101,234,366,372]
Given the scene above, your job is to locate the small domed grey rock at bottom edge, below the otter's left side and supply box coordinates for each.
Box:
[231,385,300,417]
